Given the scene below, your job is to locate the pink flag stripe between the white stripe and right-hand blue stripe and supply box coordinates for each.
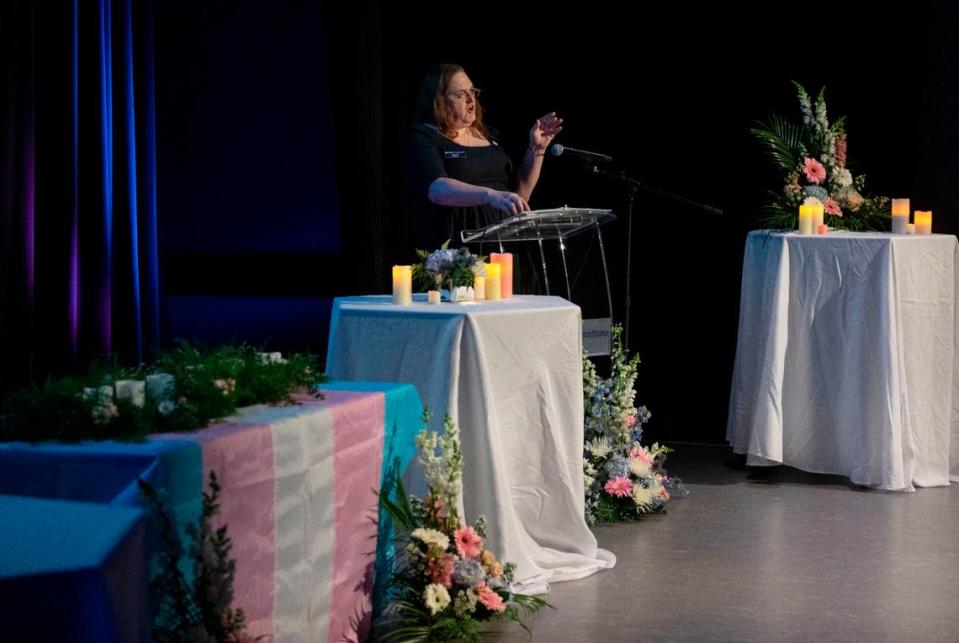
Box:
[324,391,386,642]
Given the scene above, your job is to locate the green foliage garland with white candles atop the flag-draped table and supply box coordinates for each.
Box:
[0,342,325,442]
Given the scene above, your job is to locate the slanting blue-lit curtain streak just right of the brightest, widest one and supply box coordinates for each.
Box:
[123,0,143,364]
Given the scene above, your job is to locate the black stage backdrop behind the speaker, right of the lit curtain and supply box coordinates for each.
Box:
[41,0,959,441]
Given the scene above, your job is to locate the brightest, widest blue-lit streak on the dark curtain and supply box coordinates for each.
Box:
[99,0,113,353]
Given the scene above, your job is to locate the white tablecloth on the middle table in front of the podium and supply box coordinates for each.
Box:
[326,296,615,592]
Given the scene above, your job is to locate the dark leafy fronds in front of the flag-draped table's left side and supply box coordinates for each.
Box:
[137,471,256,643]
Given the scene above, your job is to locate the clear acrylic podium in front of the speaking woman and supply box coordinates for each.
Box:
[460,206,616,318]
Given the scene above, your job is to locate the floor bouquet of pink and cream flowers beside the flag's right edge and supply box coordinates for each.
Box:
[374,413,546,642]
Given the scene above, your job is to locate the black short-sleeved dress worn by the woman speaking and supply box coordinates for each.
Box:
[405,125,514,251]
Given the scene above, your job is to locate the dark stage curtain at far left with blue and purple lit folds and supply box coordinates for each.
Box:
[0,0,160,389]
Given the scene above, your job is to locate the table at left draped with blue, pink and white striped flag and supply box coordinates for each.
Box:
[0,382,422,641]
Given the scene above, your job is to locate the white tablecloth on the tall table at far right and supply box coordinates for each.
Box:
[726,231,959,490]
